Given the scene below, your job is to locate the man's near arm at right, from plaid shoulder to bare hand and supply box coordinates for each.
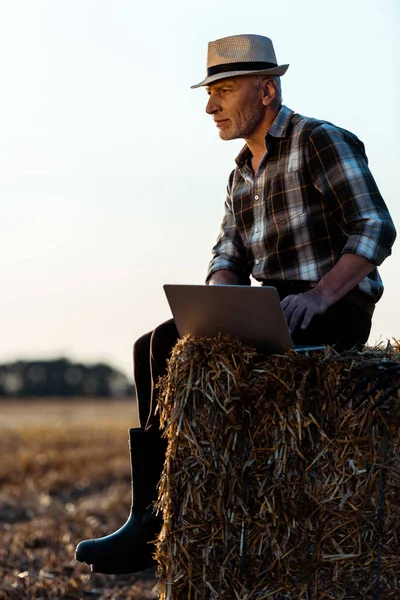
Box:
[282,124,396,331]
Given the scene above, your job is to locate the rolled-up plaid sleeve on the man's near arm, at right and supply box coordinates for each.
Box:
[309,123,396,265]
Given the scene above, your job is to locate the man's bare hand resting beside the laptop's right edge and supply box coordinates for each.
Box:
[281,288,332,333]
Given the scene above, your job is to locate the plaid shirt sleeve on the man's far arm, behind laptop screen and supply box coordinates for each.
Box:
[206,173,250,285]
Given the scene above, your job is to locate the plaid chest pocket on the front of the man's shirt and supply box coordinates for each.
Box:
[267,171,306,224]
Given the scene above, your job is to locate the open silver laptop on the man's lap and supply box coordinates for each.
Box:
[164,285,325,354]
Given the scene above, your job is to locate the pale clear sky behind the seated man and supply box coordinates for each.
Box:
[0,0,400,374]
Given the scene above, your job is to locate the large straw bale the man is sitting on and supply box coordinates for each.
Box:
[156,336,400,600]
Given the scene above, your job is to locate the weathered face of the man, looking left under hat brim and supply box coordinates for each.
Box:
[206,76,265,140]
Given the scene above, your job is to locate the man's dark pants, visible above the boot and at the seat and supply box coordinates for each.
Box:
[133,289,371,429]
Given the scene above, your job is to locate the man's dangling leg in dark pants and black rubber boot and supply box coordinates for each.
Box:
[75,320,178,573]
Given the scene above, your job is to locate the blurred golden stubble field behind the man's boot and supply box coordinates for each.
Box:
[0,399,157,600]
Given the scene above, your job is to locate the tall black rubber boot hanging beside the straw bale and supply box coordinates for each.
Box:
[75,429,167,574]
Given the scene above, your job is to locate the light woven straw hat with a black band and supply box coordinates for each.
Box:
[191,34,289,88]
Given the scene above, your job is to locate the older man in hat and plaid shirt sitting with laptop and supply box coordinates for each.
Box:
[76,35,396,573]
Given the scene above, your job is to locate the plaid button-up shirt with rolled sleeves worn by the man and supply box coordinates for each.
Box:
[206,106,396,301]
